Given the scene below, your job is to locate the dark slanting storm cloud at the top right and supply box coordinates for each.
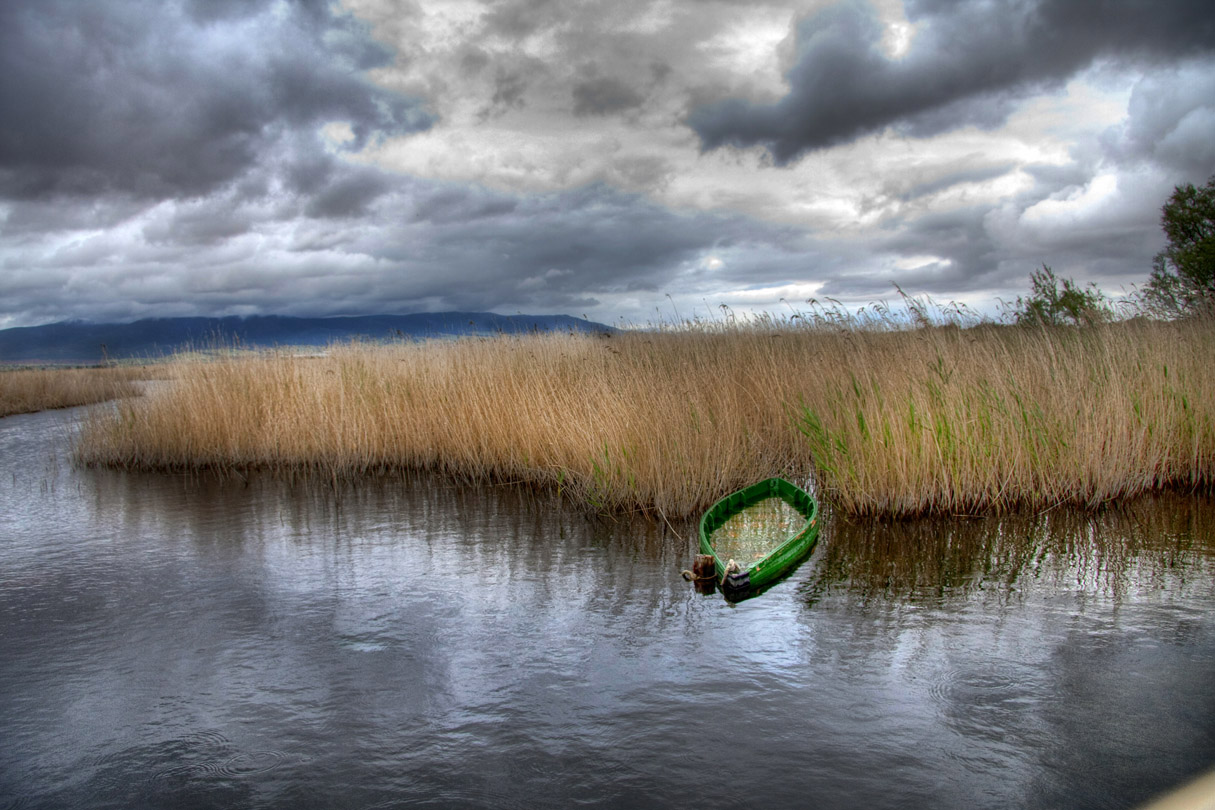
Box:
[686,0,1215,164]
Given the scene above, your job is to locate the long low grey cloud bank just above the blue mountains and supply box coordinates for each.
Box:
[0,175,801,323]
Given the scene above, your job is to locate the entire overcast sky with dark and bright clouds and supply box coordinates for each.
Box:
[0,0,1215,328]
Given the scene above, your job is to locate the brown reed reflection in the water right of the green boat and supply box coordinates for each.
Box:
[804,494,1215,601]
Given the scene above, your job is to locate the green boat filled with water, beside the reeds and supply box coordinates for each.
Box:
[700,478,819,594]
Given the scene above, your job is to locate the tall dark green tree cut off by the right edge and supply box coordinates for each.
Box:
[1143,176,1215,316]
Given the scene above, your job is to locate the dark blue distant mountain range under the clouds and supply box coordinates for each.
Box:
[0,312,614,366]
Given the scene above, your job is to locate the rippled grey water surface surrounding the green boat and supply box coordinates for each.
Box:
[0,410,1215,810]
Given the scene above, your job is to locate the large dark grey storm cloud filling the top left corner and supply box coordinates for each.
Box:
[0,0,429,201]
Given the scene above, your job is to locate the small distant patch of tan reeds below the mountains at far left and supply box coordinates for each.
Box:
[0,367,146,417]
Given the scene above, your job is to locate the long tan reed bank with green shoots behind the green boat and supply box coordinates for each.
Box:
[77,321,1215,516]
